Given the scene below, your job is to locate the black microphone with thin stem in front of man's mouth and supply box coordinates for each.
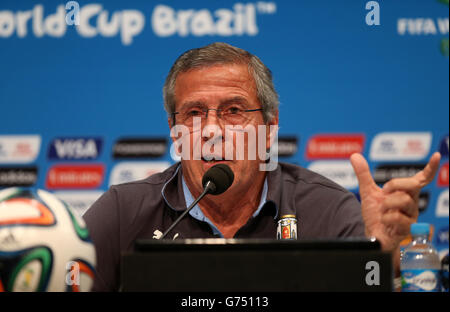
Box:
[160,164,234,239]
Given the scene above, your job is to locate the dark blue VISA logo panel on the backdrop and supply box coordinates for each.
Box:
[48,138,103,160]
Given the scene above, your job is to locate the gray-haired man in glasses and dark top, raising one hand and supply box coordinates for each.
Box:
[84,43,440,291]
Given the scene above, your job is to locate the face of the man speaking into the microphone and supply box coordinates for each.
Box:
[171,64,277,192]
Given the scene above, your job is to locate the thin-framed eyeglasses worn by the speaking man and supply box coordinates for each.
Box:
[172,106,262,127]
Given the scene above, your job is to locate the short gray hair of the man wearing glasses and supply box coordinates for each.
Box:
[163,42,279,122]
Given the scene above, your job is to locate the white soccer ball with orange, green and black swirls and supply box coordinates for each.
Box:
[0,187,96,292]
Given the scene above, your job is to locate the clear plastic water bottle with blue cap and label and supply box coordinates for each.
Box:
[400,223,441,292]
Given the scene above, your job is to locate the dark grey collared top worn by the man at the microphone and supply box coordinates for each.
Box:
[83,163,364,291]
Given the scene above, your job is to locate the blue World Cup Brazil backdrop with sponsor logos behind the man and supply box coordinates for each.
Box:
[0,0,449,253]
